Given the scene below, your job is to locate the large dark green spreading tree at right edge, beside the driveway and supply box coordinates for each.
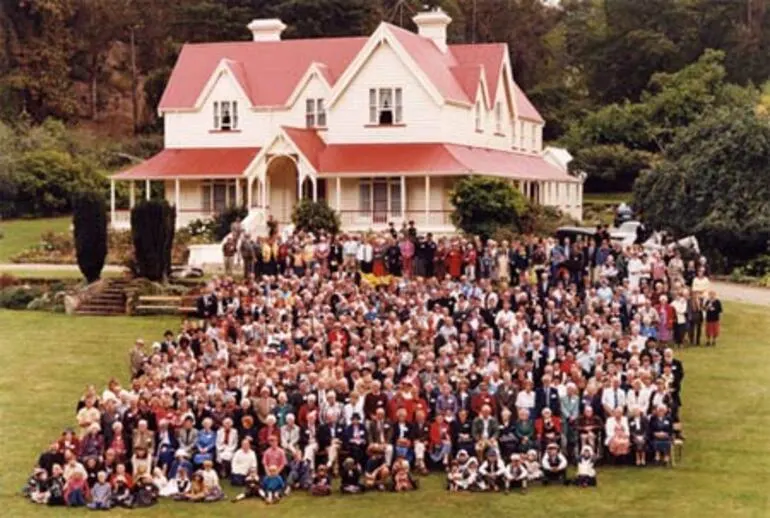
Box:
[634,107,770,269]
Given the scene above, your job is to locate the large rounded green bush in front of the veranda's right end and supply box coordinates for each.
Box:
[450,176,527,239]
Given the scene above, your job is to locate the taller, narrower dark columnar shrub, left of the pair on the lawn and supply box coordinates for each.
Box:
[72,191,107,283]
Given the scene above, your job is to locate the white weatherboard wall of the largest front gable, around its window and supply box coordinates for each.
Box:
[325,42,442,144]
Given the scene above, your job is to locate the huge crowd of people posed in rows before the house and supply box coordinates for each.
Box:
[25,224,722,509]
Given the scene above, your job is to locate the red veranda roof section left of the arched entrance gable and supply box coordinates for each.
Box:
[113,147,260,180]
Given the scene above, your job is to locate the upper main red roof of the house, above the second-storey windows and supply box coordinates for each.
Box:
[158,24,542,121]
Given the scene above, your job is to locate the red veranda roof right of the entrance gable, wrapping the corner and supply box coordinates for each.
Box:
[310,143,578,182]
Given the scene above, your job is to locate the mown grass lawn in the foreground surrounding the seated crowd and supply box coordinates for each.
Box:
[0,304,770,518]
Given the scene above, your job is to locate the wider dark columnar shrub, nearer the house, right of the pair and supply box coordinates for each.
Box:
[131,200,176,282]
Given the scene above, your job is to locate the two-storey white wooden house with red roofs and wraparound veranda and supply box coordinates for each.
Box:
[111,10,583,239]
